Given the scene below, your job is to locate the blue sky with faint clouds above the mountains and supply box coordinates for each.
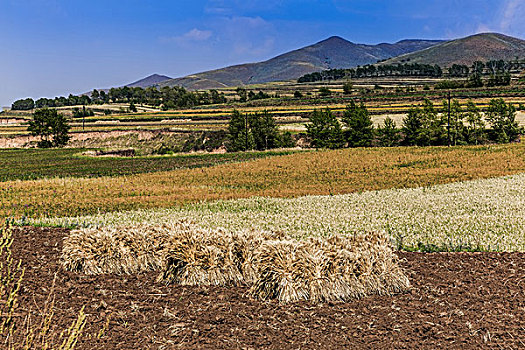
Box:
[0,0,525,106]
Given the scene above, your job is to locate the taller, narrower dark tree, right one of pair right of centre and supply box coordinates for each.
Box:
[342,101,374,147]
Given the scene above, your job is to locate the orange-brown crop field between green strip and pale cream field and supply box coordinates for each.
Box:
[0,144,525,218]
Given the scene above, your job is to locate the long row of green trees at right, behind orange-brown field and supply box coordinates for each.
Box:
[306,99,523,149]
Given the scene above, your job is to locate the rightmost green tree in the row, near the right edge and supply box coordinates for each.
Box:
[487,98,522,143]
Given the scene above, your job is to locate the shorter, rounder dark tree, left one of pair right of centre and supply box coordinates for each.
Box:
[306,108,344,149]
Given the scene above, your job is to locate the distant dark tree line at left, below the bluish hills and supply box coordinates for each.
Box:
[11,86,226,110]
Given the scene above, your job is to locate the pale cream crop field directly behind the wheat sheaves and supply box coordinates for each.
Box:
[41,174,525,252]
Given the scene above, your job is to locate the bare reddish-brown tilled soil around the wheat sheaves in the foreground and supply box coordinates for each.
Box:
[12,228,525,349]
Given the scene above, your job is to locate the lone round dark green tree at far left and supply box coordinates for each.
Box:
[27,108,70,148]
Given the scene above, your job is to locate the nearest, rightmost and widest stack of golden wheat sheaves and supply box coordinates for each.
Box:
[250,234,409,302]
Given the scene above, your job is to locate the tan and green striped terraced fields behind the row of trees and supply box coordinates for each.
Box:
[0,78,525,138]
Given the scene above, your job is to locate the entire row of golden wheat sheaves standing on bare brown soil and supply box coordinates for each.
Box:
[62,222,409,302]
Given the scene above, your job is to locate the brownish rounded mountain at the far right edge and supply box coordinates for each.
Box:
[385,33,525,67]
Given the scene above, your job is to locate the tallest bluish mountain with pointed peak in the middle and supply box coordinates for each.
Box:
[160,36,441,90]
